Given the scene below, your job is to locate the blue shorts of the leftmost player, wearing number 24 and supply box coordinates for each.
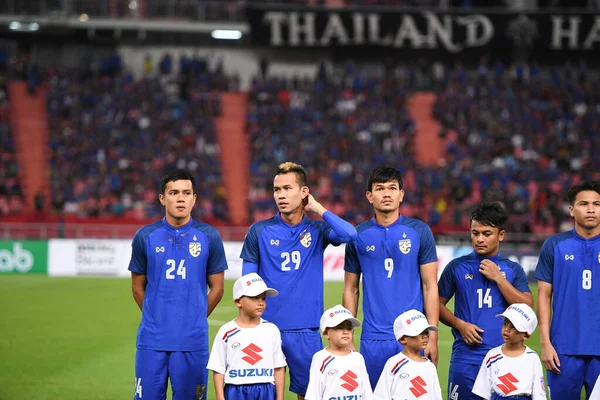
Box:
[133,349,209,400]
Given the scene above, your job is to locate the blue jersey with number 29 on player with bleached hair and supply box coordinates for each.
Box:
[241,215,339,331]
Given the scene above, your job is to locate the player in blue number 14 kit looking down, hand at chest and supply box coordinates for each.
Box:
[439,203,533,400]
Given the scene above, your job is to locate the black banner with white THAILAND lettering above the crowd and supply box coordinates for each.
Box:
[247,7,600,61]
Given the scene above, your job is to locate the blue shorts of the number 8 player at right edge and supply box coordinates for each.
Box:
[546,354,600,400]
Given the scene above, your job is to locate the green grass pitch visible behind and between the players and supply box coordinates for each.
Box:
[0,275,576,400]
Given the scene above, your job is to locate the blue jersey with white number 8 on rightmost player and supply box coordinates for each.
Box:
[534,230,600,356]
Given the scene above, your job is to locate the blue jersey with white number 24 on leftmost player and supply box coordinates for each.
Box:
[129,218,227,352]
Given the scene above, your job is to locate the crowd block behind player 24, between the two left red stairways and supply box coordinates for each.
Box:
[48,55,233,223]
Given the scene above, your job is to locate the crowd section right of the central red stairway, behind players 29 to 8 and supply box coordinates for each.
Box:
[248,60,600,233]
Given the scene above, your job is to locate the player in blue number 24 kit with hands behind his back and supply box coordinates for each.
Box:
[129,170,227,400]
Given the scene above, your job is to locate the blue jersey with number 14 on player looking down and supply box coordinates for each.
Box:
[438,252,530,364]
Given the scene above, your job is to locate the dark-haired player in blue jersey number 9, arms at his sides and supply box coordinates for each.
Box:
[343,167,439,388]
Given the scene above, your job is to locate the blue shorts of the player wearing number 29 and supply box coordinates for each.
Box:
[281,329,323,396]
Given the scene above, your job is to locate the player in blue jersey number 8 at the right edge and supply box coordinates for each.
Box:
[534,181,600,399]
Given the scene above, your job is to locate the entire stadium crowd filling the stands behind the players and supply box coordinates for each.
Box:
[0,50,600,234]
